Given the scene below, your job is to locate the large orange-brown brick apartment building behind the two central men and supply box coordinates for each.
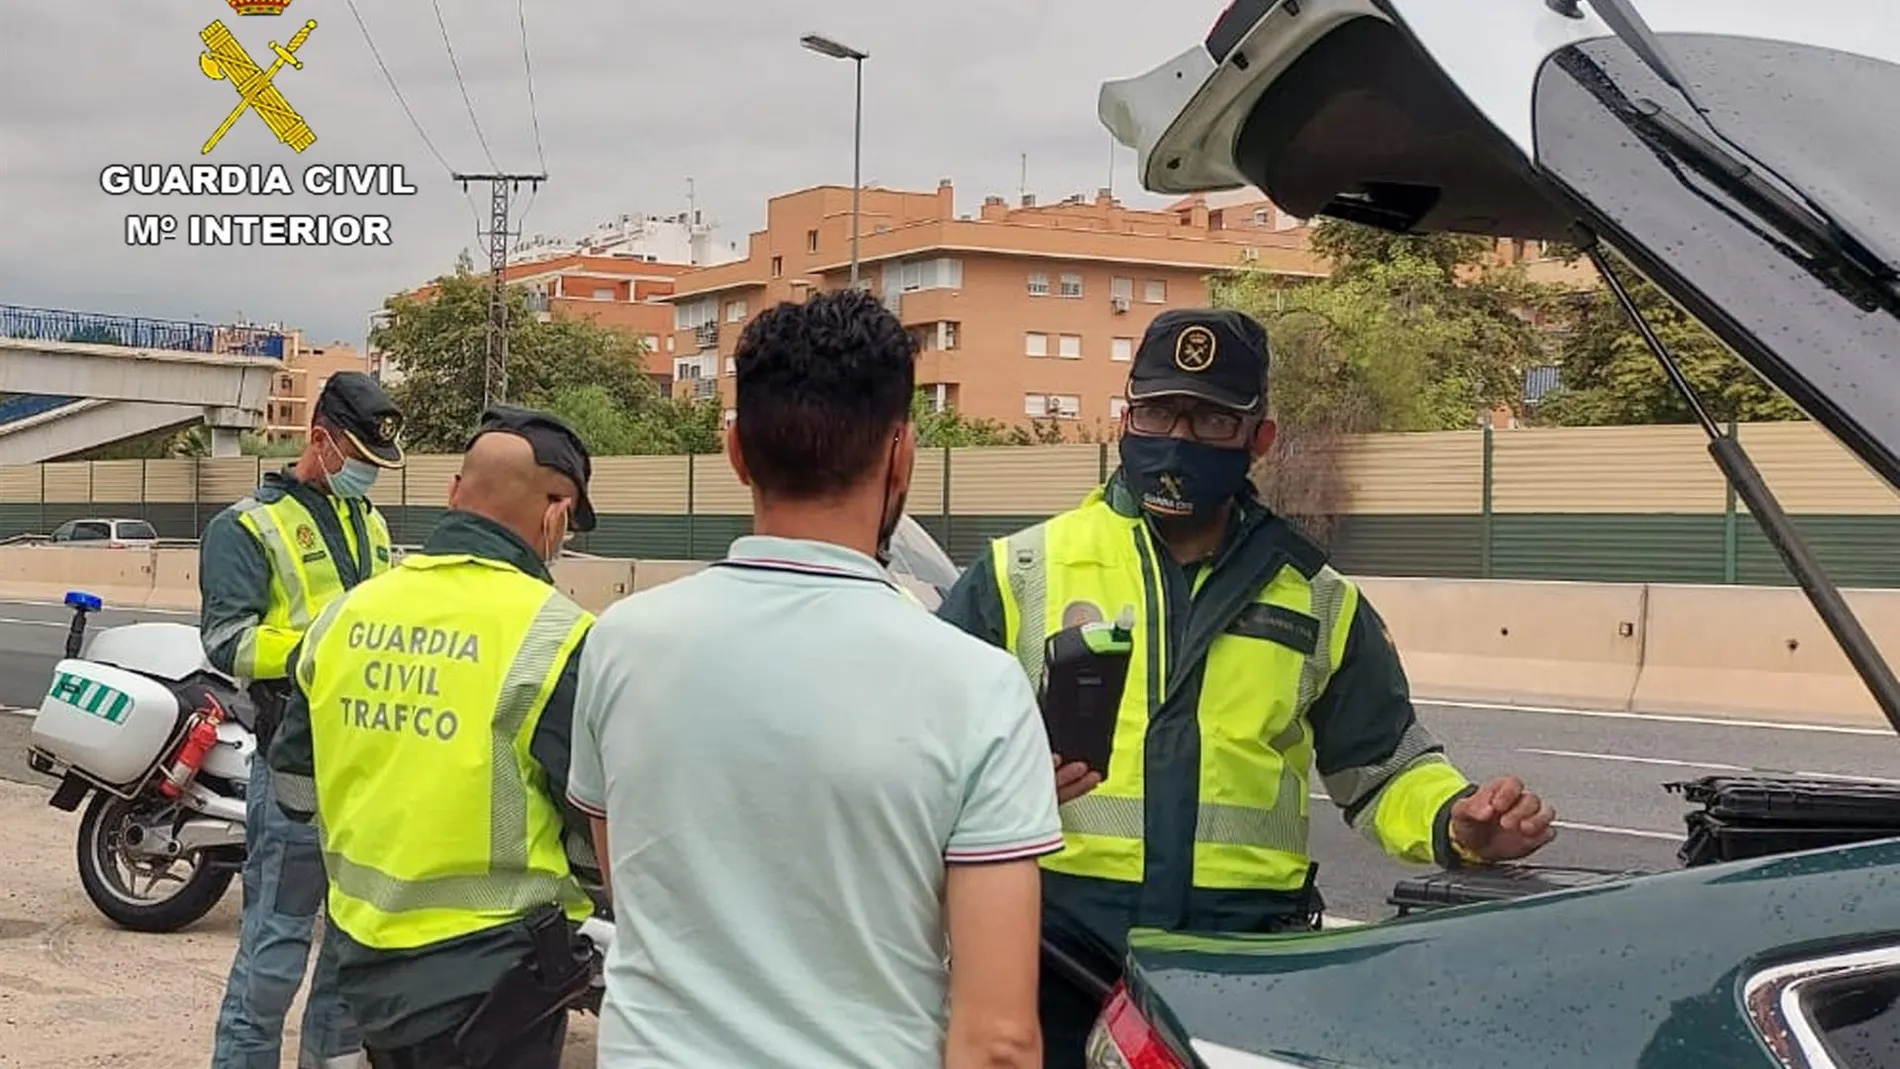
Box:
[669,180,1326,433]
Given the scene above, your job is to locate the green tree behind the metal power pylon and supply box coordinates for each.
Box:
[371,267,667,452]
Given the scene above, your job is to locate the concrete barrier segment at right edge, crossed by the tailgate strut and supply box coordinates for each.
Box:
[1632,585,1900,725]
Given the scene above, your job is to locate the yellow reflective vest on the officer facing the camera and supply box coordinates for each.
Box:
[992,488,1471,915]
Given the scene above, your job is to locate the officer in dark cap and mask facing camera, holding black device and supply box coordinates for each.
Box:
[939,309,1552,1065]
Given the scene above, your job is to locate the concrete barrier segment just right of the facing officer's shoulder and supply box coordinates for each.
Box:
[1359,579,1645,708]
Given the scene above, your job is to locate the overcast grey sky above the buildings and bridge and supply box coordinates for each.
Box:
[0,0,1224,344]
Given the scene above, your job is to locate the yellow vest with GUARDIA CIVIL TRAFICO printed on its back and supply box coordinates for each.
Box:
[296,554,593,949]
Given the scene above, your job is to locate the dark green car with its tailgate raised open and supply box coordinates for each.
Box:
[1079,0,1900,1069]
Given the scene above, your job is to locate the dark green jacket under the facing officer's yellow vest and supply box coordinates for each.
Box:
[937,473,1476,949]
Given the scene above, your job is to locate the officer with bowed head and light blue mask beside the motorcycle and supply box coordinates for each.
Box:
[198,372,403,1069]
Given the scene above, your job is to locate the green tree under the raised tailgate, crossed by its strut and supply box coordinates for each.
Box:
[1537,256,1803,425]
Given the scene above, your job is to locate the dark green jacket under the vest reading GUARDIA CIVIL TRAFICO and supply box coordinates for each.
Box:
[270,513,599,1046]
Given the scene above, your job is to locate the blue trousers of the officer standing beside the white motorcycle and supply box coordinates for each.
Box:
[211,750,363,1069]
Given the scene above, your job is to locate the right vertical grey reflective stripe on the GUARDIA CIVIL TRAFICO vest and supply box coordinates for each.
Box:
[488,591,583,872]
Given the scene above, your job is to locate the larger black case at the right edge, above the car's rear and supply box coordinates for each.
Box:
[1664,775,1900,868]
